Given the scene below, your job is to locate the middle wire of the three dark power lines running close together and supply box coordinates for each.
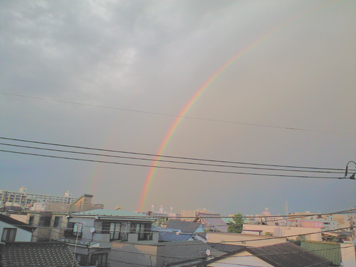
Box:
[0,143,343,174]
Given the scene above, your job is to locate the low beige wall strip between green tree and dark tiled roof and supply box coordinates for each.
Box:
[207,232,287,247]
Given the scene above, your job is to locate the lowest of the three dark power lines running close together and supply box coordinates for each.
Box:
[0,149,344,179]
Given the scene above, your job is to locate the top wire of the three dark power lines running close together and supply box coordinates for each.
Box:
[0,136,344,171]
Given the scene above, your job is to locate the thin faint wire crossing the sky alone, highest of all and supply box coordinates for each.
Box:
[0,93,355,135]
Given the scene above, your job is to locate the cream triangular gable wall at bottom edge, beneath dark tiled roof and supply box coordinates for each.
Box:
[207,251,273,267]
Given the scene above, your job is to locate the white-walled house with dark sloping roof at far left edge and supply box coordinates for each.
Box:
[0,214,36,242]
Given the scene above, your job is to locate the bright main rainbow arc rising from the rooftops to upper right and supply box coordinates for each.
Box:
[138,1,340,214]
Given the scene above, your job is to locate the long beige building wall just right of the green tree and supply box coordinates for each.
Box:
[242,224,322,241]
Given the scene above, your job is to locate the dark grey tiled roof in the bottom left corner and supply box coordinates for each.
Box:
[0,242,79,267]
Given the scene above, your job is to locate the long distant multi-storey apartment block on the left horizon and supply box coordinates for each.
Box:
[0,186,77,207]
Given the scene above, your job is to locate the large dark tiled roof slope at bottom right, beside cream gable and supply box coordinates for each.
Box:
[246,242,332,267]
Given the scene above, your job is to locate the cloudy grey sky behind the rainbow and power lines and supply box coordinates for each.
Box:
[0,0,356,215]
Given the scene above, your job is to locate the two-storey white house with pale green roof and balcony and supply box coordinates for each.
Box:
[61,209,158,266]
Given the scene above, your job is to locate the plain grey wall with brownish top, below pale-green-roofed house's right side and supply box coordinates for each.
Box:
[109,241,157,267]
